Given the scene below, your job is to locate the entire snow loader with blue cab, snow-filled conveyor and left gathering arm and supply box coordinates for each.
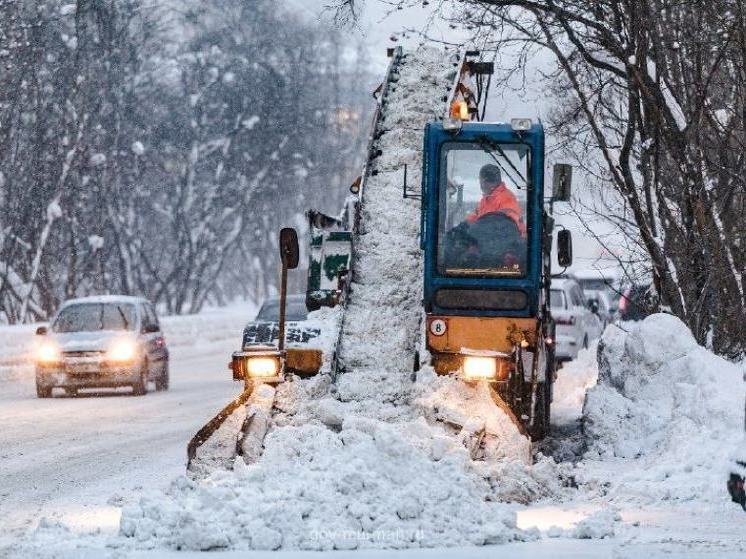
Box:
[188,48,572,471]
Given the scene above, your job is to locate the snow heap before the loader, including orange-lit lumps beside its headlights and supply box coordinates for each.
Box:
[121,370,562,550]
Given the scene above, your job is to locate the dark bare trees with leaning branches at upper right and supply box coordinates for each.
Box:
[342,0,746,355]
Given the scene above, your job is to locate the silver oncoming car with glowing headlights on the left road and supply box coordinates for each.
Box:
[36,295,169,398]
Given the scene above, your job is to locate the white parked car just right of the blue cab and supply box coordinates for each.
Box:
[550,278,603,361]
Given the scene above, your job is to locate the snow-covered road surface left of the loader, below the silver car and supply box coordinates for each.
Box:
[0,340,240,547]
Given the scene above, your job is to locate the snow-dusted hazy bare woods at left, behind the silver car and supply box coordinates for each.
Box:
[0,0,368,322]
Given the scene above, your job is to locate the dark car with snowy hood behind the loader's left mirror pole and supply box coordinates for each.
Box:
[243,295,321,348]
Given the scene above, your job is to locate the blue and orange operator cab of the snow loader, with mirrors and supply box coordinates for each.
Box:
[421,96,572,439]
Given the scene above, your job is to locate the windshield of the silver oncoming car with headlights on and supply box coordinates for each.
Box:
[52,303,136,334]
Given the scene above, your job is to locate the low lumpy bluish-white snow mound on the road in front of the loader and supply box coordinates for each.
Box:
[121,416,522,550]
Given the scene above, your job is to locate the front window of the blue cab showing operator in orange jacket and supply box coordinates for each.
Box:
[437,141,531,277]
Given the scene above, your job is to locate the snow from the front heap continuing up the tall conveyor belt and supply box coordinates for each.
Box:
[116,50,548,550]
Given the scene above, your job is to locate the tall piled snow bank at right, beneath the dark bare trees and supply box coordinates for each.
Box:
[583,314,744,501]
